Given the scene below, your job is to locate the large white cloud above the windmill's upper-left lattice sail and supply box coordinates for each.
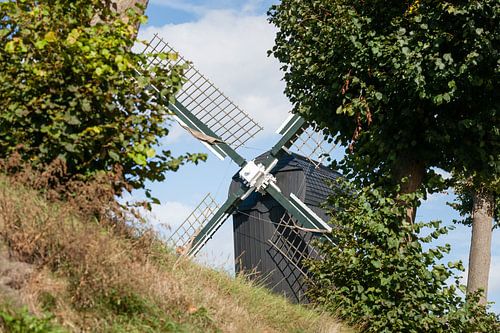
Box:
[140,9,291,136]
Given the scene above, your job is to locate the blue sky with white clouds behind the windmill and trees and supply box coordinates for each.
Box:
[133,0,500,313]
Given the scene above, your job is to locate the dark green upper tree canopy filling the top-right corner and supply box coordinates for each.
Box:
[269,0,500,186]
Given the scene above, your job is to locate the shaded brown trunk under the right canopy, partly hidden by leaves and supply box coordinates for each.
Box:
[394,158,425,224]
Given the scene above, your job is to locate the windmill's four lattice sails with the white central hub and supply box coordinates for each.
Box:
[142,35,333,300]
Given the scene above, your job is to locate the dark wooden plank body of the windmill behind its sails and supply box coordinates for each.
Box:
[230,155,339,302]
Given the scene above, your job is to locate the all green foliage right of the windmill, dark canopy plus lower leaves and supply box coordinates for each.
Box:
[269,0,500,324]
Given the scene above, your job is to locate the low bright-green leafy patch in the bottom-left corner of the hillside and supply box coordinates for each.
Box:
[0,308,66,333]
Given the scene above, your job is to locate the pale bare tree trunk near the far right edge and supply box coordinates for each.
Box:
[467,190,494,304]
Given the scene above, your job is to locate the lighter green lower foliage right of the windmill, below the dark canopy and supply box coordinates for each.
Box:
[309,181,500,332]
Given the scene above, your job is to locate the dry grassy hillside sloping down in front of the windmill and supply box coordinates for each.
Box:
[0,176,350,332]
